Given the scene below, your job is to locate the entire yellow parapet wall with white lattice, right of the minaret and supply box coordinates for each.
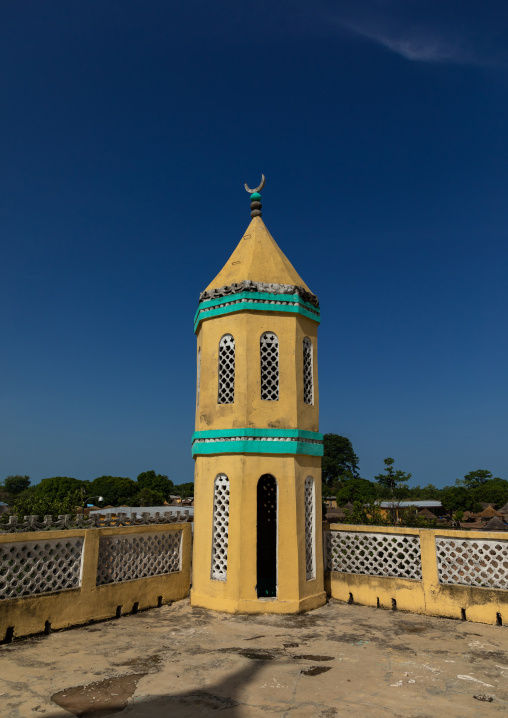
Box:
[325,524,508,625]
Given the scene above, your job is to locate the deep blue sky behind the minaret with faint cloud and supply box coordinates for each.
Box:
[0,0,508,485]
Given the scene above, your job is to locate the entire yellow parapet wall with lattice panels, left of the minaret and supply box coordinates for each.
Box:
[0,522,191,642]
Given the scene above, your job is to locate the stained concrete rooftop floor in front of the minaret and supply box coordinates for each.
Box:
[0,600,508,718]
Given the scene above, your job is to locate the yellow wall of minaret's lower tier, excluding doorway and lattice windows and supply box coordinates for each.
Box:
[191,454,326,613]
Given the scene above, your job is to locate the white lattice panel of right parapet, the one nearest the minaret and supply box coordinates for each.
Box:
[326,531,422,580]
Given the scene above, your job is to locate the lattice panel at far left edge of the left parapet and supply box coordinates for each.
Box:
[0,537,83,599]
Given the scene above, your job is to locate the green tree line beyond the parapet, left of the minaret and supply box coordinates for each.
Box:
[0,470,194,517]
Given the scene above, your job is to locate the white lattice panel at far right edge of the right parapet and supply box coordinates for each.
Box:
[436,537,508,590]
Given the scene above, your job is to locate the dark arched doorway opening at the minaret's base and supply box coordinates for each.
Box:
[256,474,277,598]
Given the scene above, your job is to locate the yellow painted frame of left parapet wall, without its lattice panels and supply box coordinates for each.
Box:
[0,523,191,641]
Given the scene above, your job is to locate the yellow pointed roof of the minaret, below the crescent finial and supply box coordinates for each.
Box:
[205,217,310,292]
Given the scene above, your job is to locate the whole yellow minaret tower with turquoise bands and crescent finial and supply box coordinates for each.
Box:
[191,176,325,613]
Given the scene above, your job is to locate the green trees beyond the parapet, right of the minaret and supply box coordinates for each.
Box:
[322,434,508,518]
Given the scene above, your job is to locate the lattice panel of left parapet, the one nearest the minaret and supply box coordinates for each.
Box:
[96,531,182,586]
